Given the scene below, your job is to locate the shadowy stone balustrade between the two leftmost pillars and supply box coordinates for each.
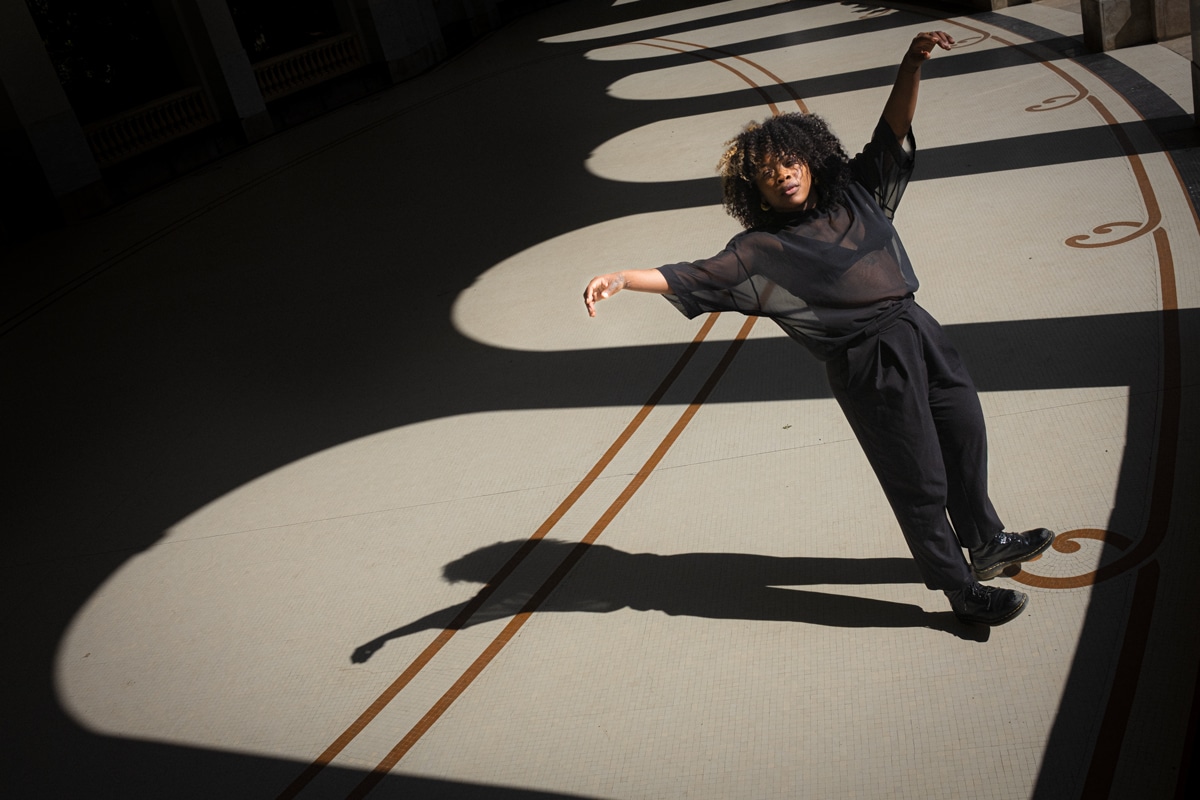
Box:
[84,86,216,167]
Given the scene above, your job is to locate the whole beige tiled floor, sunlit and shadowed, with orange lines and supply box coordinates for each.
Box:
[0,0,1200,798]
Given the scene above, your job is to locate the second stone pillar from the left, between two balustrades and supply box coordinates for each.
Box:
[165,0,275,142]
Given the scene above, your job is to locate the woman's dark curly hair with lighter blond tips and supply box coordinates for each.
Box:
[716,113,851,228]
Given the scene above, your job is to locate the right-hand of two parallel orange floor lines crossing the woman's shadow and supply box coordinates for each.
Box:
[347,317,757,800]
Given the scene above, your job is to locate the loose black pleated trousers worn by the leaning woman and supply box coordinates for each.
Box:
[826,303,1003,590]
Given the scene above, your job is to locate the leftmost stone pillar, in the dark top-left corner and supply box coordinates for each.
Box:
[0,0,108,225]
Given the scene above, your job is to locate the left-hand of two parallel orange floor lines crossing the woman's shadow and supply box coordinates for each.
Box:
[278,314,720,800]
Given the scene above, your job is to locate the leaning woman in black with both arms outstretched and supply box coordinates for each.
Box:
[583,31,1054,625]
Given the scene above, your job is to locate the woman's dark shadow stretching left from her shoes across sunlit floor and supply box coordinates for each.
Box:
[350,540,989,663]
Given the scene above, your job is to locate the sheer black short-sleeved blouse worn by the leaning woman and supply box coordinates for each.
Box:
[659,119,918,361]
